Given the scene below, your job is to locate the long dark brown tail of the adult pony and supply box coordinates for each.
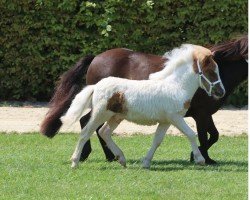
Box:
[40,55,95,138]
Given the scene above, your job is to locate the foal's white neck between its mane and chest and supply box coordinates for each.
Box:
[166,66,199,99]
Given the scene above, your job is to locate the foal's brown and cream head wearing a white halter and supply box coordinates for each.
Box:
[193,46,226,99]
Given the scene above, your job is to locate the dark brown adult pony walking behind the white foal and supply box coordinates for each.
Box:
[41,36,248,164]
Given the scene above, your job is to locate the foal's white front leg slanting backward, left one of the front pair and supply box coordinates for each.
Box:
[142,124,170,168]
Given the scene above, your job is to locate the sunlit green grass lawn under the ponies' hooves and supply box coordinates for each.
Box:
[0,134,248,200]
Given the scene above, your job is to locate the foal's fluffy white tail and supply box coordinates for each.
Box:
[61,85,95,125]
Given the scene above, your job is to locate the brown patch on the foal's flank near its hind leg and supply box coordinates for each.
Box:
[107,92,127,113]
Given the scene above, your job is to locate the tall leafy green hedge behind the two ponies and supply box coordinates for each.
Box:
[0,0,248,104]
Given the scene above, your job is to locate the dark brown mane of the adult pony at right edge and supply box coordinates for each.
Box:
[210,35,248,60]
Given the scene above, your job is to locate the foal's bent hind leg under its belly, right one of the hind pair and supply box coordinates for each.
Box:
[99,117,126,167]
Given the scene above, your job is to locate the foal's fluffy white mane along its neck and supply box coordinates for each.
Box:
[149,44,194,80]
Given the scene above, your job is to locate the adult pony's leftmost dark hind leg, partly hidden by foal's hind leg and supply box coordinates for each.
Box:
[80,112,92,161]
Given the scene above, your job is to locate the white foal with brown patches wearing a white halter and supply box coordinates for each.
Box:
[61,45,225,168]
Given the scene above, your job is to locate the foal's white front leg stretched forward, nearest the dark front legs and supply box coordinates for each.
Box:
[171,116,205,165]
